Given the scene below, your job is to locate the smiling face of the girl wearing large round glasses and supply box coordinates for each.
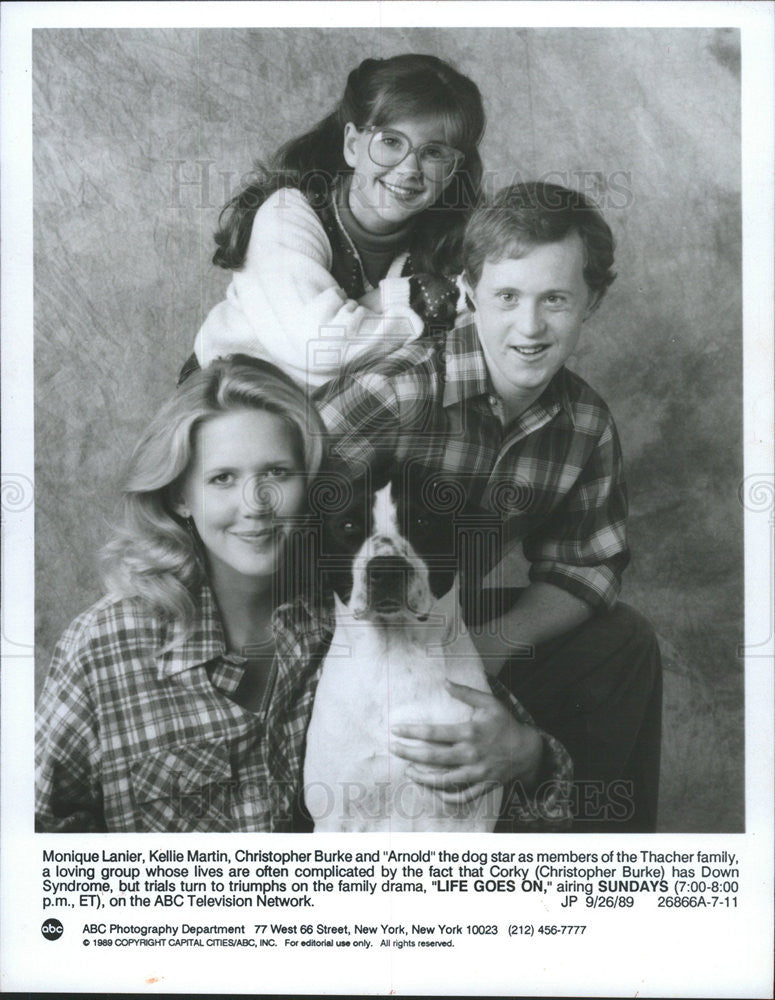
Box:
[344,119,452,234]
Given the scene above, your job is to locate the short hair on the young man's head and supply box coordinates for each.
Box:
[463,181,616,299]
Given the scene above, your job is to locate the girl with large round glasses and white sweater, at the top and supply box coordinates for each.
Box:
[192,54,484,389]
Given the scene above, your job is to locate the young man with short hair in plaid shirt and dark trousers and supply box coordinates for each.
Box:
[319,183,661,831]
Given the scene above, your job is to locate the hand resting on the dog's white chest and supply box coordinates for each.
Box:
[391,681,543,802]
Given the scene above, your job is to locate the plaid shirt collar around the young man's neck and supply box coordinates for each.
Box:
[442,313,575,424]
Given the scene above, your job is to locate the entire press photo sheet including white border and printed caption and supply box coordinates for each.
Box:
[0,3,775,996]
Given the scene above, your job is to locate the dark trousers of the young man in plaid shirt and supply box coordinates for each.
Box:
[475,589,662,833]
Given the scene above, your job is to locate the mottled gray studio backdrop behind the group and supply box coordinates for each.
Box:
[31,28,744,831]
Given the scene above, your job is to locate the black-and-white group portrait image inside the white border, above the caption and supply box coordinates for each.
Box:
[28,19,745,832]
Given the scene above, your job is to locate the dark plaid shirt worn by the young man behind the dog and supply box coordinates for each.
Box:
[318,318,629,607]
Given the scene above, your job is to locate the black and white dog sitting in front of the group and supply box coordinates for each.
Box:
[304,464,502,832]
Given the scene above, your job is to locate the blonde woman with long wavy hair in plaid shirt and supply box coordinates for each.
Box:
[36,357,323,832]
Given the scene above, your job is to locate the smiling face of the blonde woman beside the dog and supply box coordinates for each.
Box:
[174,410,306,593]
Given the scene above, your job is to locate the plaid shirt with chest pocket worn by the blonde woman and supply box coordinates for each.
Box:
[36,586,572,832]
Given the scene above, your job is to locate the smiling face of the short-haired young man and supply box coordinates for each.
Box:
[469,232,596,417]
